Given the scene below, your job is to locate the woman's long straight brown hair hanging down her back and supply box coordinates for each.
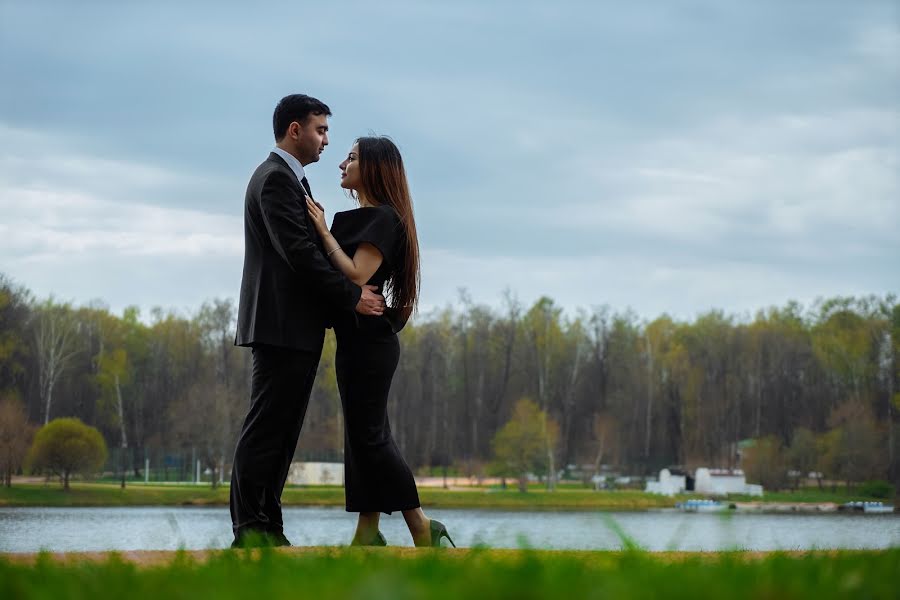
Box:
[356,136,421,321]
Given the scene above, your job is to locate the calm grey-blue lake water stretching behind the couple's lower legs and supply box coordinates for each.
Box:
[0,507,900,552]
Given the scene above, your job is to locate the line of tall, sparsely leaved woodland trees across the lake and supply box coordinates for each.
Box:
[0,275,900,490]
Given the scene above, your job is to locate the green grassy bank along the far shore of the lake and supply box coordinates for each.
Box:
[0,482,884,510]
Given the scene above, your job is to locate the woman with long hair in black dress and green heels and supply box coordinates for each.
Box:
[307,137,453,546]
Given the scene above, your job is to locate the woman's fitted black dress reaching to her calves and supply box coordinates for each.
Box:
[331,205,419,514]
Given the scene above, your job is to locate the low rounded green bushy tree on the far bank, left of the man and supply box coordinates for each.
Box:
[26,418,107,490]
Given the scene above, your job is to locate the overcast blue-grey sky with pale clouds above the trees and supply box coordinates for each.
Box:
[0,0,900,319]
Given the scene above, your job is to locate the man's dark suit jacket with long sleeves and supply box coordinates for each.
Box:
[234,152,362,352]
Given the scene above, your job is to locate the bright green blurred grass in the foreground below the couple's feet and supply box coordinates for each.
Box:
[0,548,900,600]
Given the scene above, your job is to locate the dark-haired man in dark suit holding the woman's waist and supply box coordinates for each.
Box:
[231,94,384,546]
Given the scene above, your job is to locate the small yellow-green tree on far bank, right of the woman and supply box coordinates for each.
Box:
[492,398,559,492]
